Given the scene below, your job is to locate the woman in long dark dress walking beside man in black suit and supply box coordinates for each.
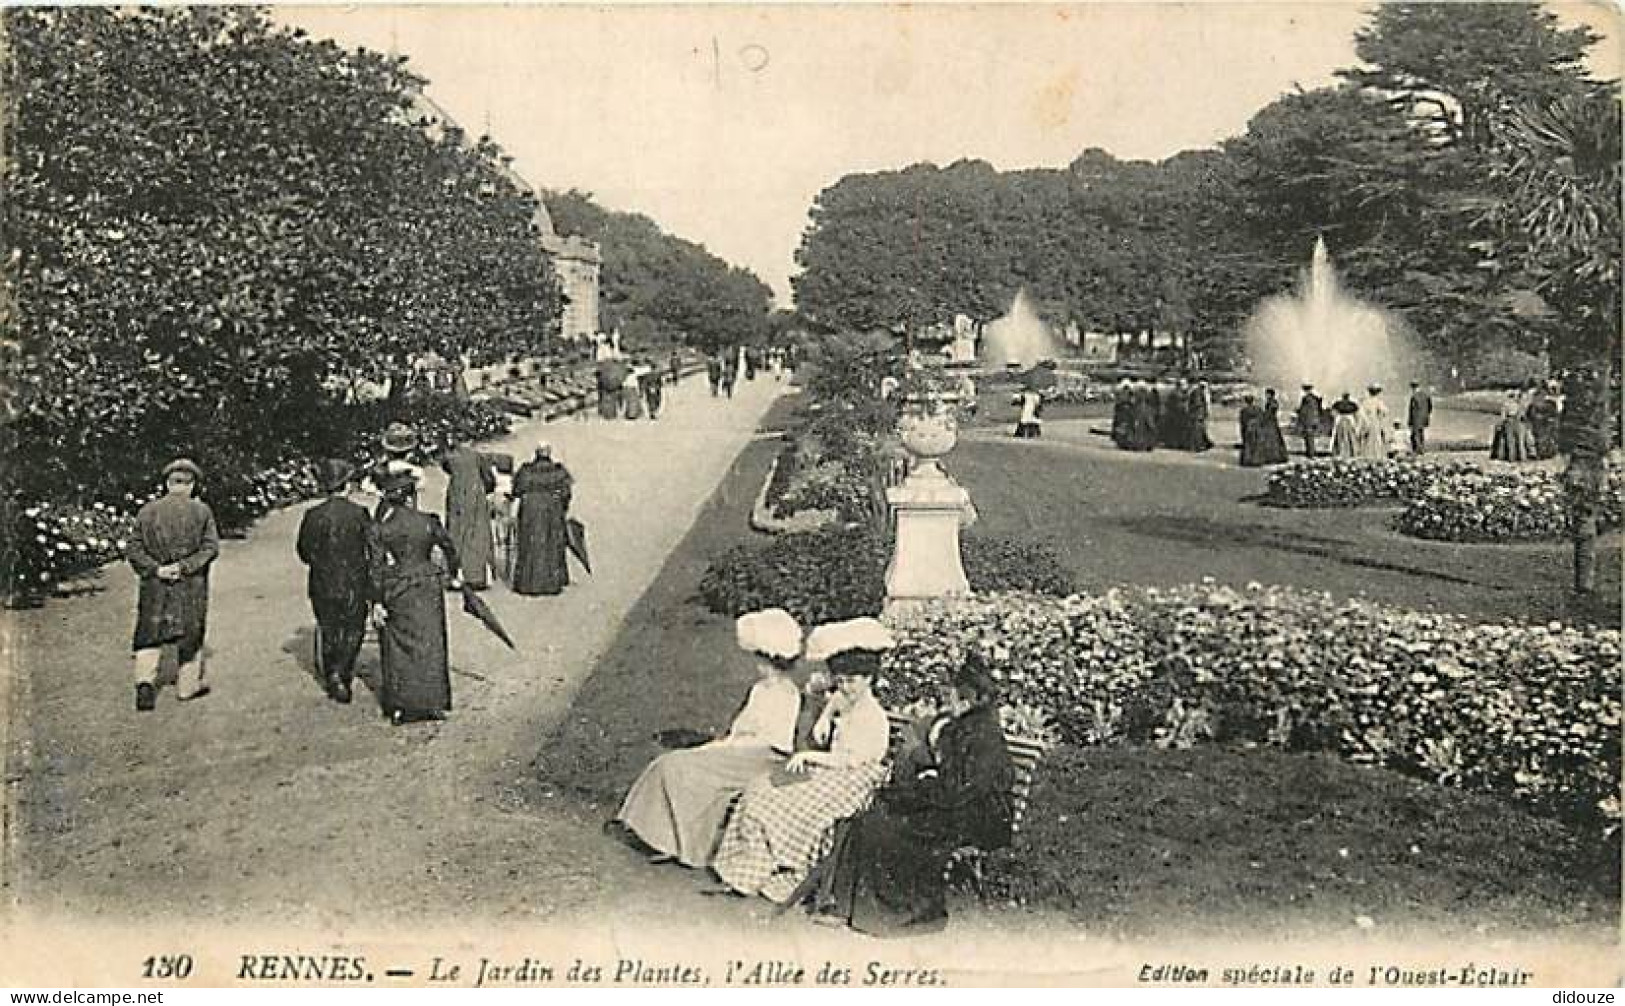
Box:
[371,473,458,725]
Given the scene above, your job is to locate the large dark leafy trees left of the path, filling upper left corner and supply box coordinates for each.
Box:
[0,7,559,572]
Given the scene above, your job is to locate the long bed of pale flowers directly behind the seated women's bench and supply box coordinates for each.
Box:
[884,583,1620,832]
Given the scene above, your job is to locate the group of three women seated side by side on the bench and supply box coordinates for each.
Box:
[611,608,1014,936]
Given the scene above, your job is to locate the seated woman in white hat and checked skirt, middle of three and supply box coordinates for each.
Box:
[712,618,894,904]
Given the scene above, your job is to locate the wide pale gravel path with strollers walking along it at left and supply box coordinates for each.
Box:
[0,379,783,933]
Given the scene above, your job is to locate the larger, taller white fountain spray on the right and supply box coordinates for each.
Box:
[1246,237,1404,400]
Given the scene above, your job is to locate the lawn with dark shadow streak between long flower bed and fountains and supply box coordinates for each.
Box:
[946,437,1620,627]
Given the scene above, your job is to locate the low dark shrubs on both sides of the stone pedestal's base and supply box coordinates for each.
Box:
[700,528,1073,630]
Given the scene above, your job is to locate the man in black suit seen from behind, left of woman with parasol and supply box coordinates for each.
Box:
[296,460,374,702]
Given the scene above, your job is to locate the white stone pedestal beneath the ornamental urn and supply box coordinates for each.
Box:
[886,460,970,613]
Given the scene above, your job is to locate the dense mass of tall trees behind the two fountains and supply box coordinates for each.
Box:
[795,3,1620,377]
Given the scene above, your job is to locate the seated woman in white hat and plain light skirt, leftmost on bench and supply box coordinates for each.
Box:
[616,608,801,868]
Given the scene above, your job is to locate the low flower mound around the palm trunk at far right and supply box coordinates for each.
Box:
[1398,463,1625,541]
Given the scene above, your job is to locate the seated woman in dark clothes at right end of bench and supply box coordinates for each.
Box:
[814,657,1016,936]
